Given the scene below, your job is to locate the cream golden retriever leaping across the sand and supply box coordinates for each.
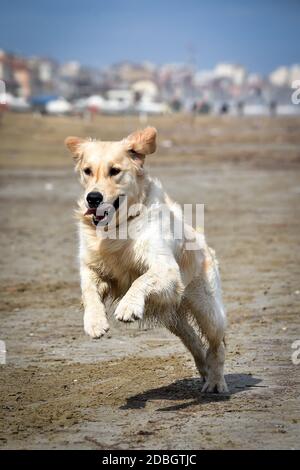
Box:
[65,127,227,393]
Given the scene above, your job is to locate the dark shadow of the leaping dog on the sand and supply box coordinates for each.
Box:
[120,374,262,411]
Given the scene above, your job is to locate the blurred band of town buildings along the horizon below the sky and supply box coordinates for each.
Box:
[0,50,300,115]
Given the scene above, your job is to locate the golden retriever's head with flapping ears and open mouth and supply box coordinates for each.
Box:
[65,127,156,225]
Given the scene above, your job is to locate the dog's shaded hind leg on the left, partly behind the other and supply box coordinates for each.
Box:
[164,312,207,380]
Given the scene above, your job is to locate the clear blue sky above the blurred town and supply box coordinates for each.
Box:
[0,0,300,74]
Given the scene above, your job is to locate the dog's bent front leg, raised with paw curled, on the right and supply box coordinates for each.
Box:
[115,258,184,322]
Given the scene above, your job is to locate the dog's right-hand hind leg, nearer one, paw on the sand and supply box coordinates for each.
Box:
[186,271,228,393]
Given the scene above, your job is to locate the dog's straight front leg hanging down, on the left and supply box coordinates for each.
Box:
[80,264,109,338]
